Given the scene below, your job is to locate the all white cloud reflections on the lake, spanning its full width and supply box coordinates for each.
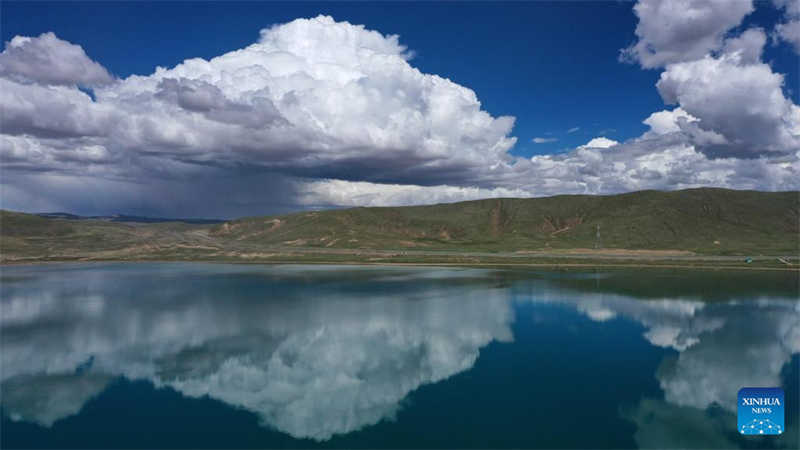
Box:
[0,265,800,442]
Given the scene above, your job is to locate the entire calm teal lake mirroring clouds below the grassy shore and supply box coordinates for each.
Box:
[0,263,800,448]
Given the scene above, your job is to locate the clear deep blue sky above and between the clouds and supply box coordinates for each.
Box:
[2,1,798,156]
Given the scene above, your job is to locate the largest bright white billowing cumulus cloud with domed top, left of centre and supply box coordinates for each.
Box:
[90,16,516,183]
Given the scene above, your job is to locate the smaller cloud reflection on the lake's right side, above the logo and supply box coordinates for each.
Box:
[534,284,800,411]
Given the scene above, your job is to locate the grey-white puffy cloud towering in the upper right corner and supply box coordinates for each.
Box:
[623,0,800,158]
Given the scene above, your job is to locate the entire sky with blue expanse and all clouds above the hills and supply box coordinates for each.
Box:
[0,0,800,218]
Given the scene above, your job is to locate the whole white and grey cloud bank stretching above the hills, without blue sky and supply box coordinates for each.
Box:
[0,13,800,217]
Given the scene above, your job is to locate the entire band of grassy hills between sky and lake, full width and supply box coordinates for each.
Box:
[0,189,800,260]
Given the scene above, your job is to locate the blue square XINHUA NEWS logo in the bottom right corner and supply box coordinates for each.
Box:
[738,388,784,435]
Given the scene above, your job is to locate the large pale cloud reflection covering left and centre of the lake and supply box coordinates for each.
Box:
[2,264,513,440]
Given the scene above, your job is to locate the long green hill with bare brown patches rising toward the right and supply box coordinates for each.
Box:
[211,189,800,255]
